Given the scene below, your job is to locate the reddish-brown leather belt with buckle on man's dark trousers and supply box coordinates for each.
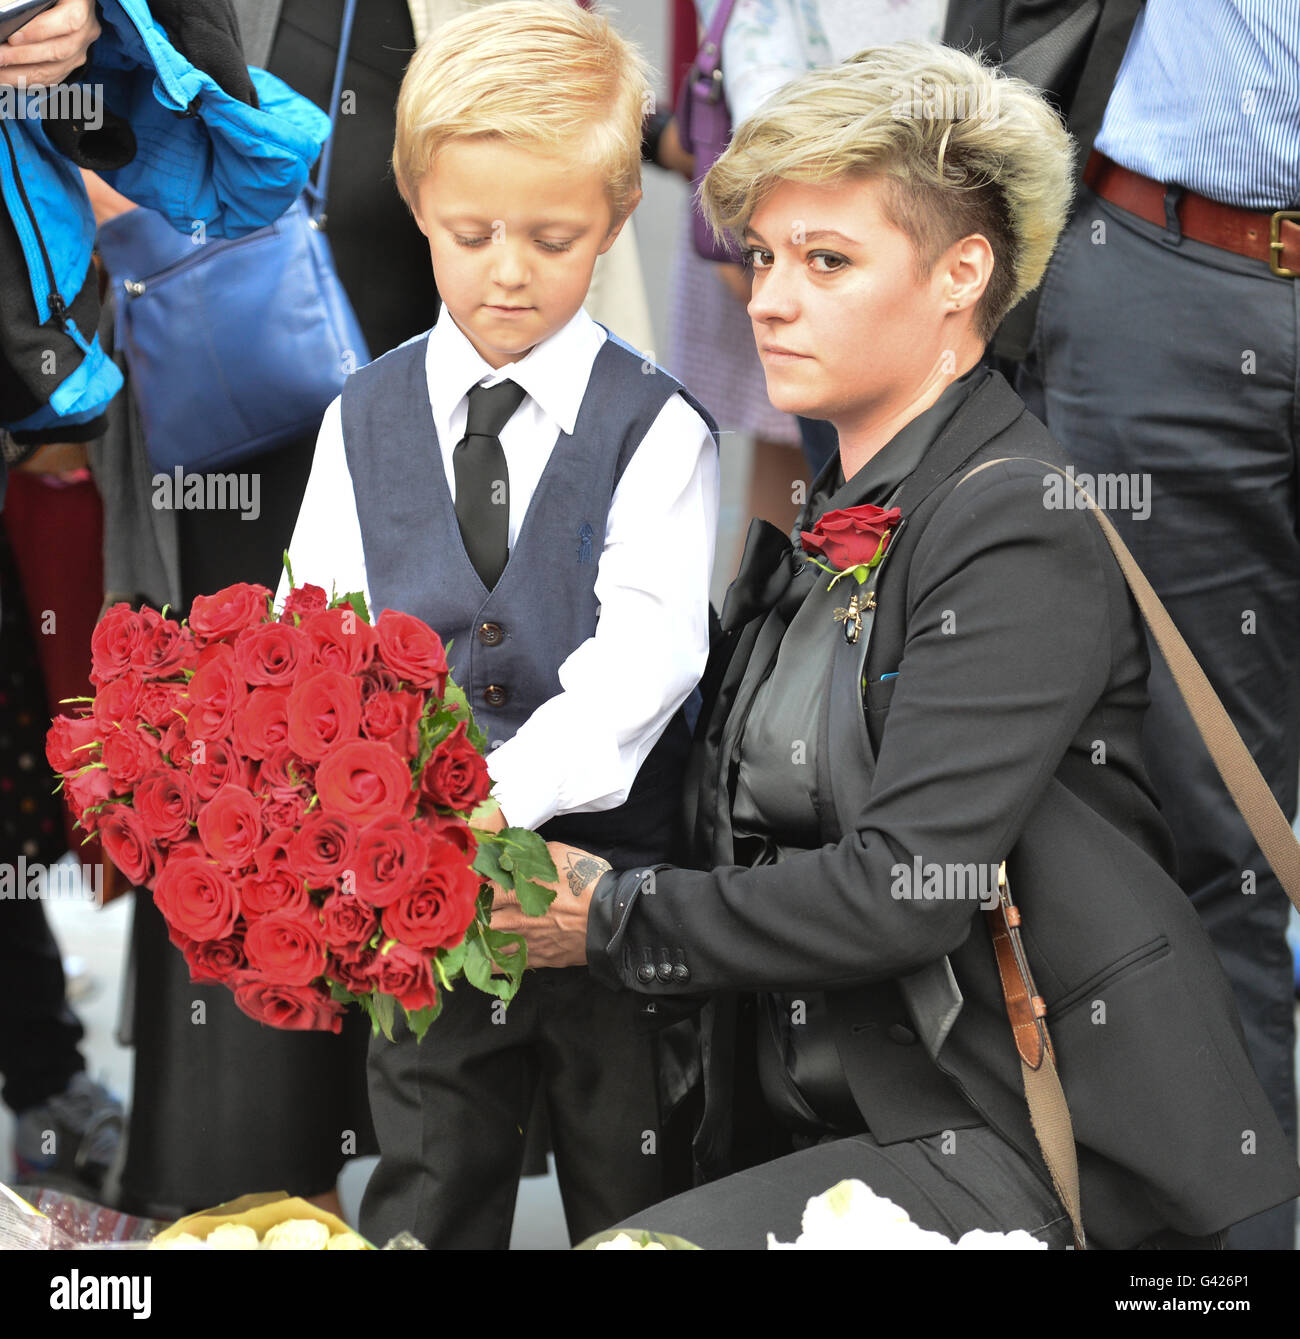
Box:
[1083,149,1300,279]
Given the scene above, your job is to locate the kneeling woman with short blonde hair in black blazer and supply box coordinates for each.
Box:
[499,44,1300,1249]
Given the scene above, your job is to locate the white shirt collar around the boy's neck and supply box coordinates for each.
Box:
[427,304,605,432]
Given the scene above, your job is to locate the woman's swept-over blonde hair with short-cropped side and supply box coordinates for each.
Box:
[702,42,1074,340]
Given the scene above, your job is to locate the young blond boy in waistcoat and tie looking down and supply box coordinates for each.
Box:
[282,0,718,1248]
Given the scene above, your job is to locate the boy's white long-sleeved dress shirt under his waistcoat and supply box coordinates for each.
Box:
[277,307,719,828]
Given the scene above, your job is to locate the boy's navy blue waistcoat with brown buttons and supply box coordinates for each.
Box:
[341,336,716,865]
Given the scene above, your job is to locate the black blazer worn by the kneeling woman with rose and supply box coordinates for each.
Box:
[588,374,1300,1248]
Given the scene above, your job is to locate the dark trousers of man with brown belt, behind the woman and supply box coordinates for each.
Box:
[1026,190,1300,1249]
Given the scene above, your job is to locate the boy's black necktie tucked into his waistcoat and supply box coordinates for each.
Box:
[451,382,527,590]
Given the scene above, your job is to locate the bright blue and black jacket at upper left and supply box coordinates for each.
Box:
[0,0,329,441]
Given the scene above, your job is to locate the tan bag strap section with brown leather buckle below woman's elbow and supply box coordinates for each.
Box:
[984,862,1087,1251]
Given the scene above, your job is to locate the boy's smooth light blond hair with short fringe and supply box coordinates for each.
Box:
[392,0,652,224]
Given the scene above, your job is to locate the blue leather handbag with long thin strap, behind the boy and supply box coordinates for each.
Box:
[98,0,370,474]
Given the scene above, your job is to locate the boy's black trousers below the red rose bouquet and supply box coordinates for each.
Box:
[360,967,667,1249]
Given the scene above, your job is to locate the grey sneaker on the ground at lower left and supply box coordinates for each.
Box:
[13,1071,126,1194]
